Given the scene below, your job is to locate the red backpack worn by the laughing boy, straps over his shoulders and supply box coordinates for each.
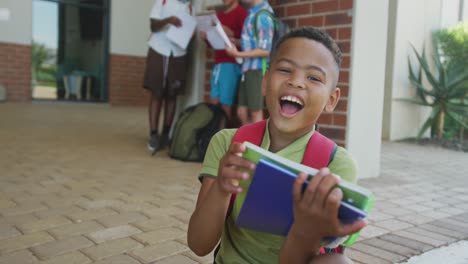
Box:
[214,120,344,259]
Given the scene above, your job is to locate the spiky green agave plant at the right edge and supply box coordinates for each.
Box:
[402,39,468,139]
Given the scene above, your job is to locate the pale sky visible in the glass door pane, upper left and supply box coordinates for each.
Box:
[32,0,58,49]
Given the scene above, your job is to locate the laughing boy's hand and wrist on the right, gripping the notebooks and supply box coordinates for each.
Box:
[290,168,366,248]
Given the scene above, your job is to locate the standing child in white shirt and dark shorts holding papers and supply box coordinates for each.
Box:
[143,0,191,154]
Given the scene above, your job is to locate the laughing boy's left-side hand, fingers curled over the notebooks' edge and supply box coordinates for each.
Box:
[216,142,255,193]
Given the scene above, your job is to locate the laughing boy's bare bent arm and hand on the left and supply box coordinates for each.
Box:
[187,143,255,256]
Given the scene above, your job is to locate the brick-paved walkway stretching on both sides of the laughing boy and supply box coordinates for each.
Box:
[0,102,468,264]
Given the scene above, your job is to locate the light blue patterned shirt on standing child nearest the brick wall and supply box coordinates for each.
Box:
[241,1,274,73]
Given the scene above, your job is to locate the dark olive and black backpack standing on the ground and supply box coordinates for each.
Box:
[169,103,227,162]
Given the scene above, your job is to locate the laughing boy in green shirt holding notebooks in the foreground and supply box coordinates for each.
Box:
[187,28,366,263]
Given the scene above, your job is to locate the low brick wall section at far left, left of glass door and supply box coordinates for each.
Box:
[0,42,31,102]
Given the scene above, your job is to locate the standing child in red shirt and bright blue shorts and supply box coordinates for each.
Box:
[200,0,247,119]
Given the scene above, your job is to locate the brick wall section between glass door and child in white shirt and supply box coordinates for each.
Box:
[109,54,148,106]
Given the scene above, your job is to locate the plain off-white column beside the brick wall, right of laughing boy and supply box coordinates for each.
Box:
[346,0,389,178]
